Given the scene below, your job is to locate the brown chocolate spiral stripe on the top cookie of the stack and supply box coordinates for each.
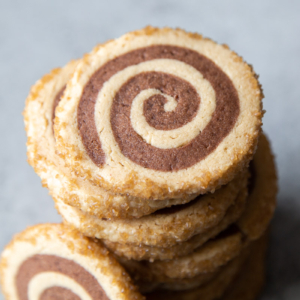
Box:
[77,45,240,172]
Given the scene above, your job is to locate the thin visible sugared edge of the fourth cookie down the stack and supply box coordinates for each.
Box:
[102,191,246,262]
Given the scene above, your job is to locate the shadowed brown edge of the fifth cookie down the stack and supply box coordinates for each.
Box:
[117,228,243,282]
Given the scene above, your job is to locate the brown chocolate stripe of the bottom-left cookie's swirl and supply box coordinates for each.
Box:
[16,254,109,300]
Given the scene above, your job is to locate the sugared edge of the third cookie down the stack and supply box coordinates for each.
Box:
[56,172,248,247]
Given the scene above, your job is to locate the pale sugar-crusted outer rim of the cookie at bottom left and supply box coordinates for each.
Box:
[0,224,143,300]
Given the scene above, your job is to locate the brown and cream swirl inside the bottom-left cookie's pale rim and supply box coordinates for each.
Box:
[15,254,108,300]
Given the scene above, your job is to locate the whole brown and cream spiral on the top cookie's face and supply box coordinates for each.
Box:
[77,45,240,172]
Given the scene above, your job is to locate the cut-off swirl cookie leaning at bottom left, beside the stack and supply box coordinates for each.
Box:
[0,224,144,300]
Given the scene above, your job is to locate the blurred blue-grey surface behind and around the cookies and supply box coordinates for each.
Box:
[0,0,300,300]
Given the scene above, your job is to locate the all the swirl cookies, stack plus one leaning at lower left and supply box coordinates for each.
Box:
[1,27,277,300]
